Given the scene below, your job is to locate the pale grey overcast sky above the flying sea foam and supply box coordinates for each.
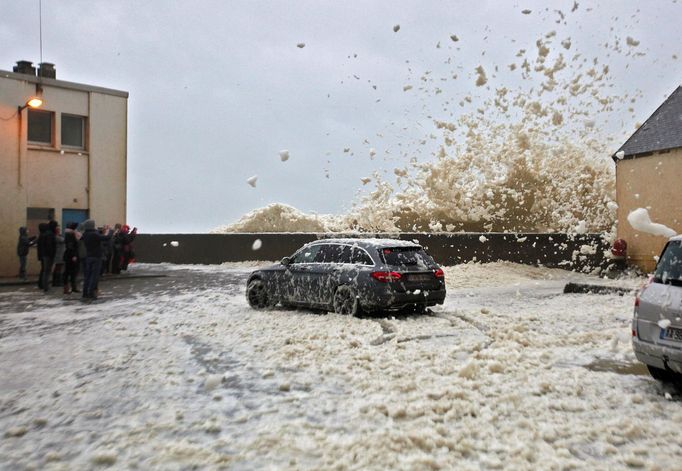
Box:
[0,0,682,232]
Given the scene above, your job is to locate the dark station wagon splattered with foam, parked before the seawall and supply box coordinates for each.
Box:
[246,239,445,315]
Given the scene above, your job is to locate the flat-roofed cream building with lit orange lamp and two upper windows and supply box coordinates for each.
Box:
[0,61,128,276]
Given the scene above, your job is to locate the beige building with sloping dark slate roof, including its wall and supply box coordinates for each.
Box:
[612,87,682,272]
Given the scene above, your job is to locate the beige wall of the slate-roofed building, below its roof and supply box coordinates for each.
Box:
[616,149,682,272]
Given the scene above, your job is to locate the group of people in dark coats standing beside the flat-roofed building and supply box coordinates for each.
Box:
[17,219,137,299]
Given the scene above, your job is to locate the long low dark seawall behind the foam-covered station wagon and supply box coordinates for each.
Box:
[135,233,609,269]
